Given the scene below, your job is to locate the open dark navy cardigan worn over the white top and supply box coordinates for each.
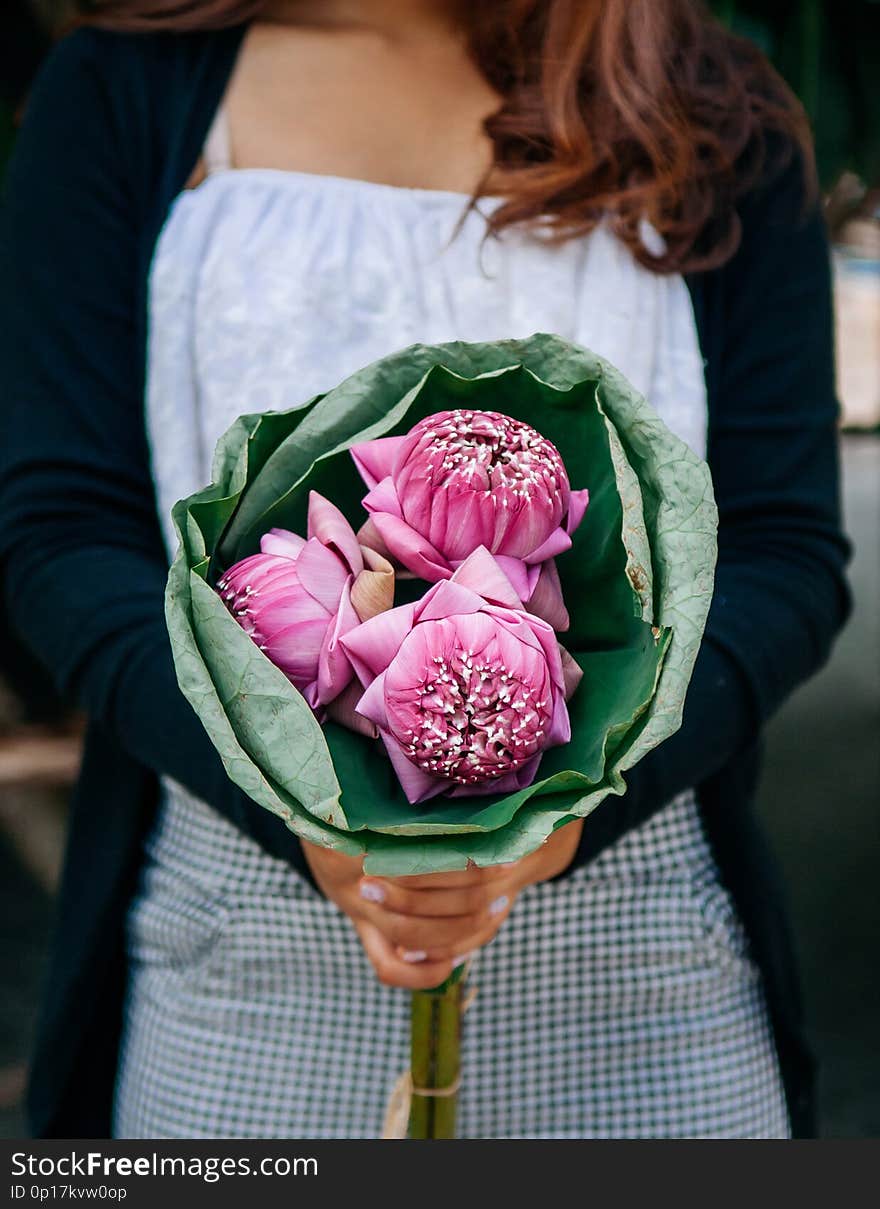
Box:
[0,29,847,1138]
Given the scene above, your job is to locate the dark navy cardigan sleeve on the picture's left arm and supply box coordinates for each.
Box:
[0,31,307,874]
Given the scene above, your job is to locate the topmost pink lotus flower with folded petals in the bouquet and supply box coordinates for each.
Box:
[352,410,589,630]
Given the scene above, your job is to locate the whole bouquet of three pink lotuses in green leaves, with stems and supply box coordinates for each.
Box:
[167,335,717,1136]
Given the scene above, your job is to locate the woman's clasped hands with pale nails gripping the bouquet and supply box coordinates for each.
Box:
[302,821,583,990]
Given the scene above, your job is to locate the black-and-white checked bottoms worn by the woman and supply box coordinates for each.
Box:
[114,785,789,1138]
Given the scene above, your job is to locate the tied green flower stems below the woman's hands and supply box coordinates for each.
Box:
[409,973,462,1140]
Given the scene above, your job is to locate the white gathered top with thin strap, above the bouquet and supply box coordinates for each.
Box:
[146,111,706,553]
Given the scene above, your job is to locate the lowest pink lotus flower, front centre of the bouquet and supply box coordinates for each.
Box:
[341,548,581,803]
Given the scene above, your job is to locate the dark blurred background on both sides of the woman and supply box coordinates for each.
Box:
[0,0,880,1138]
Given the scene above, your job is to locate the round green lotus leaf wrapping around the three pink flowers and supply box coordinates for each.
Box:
[166,335,717,875]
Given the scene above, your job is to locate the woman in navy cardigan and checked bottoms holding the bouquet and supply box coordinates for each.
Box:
[0,0,847,1138]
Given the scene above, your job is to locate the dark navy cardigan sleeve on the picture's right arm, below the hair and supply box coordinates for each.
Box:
[563,148,850,877]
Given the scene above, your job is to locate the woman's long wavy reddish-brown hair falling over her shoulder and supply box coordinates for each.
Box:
[72,0,815,272]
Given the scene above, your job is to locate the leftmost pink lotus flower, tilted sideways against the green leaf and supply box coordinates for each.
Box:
[218,491,394,729]
